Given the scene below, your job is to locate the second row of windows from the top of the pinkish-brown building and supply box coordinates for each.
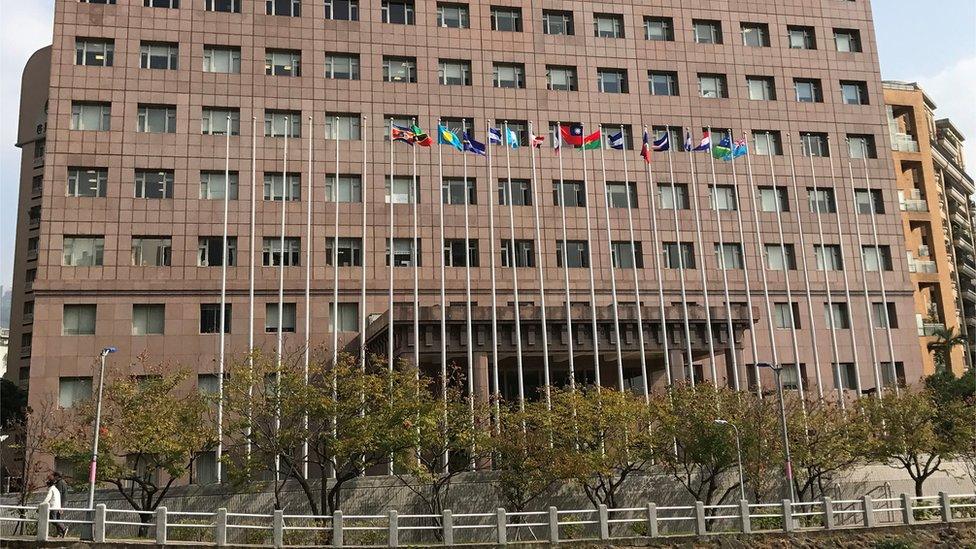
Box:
[75,38,868,105]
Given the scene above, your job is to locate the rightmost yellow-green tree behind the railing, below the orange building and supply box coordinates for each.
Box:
[863,388,976,496]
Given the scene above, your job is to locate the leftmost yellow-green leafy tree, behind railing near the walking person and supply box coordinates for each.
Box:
[48,361,217,535]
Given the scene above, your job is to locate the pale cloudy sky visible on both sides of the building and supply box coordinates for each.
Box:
[0,0,976,288]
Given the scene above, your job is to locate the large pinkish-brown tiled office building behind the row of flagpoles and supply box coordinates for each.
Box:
[8,0,923,428]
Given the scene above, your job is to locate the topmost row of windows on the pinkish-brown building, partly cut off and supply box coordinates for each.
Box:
[80,0,862,53]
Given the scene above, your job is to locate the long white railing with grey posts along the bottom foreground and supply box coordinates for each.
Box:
[0,493,976,547]
